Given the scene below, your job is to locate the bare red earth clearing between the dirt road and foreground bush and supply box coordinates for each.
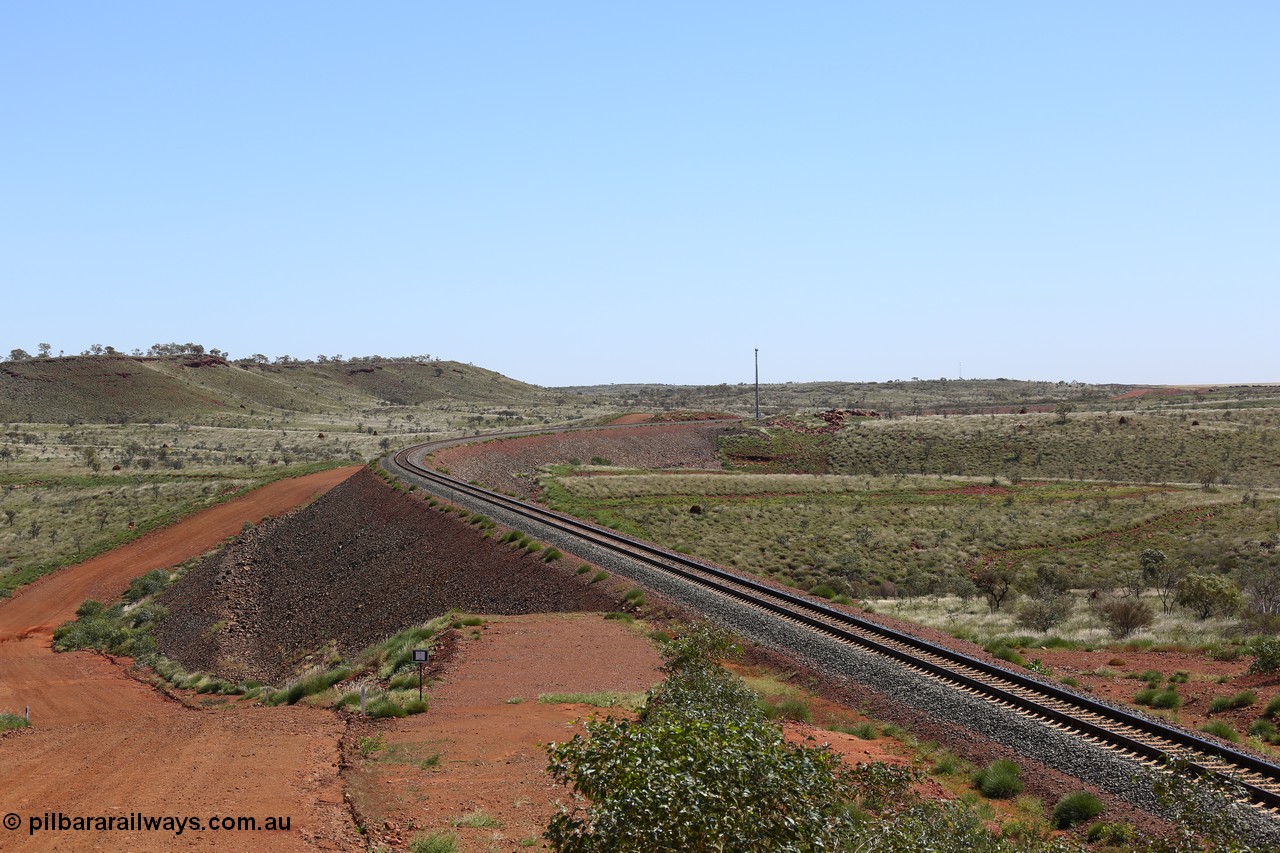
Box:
[344,613,916,853]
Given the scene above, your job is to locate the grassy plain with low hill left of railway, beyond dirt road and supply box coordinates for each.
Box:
[0,356,634,594]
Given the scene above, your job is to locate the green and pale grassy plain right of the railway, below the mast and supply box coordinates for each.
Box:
[543,469,1264,597]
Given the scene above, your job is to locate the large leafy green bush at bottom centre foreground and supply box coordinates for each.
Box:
[545,629,856,853]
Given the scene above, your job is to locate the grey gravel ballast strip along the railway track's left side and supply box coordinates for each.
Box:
[385,448,1280,847]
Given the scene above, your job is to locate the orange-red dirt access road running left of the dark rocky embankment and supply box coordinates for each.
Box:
[0,467,364,850]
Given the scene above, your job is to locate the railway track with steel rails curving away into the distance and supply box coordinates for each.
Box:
[384,435,1280,815]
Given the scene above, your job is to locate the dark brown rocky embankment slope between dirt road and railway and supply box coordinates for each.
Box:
[157,471,617,683]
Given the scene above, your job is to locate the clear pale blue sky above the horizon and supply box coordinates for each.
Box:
[0,0,1280,386]
